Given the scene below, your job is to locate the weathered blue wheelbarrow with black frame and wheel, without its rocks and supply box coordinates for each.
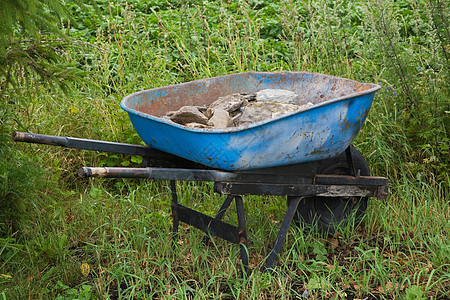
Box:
[13,72,388,273]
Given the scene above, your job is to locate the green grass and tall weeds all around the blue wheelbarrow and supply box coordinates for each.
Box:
[0,0,450,299]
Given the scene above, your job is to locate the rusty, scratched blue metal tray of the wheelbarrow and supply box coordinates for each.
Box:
[120,72,380,170]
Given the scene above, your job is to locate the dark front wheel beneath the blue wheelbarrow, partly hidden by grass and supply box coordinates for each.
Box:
[287,147,370,235]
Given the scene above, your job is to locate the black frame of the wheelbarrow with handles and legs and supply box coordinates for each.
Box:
[13,132,388,274]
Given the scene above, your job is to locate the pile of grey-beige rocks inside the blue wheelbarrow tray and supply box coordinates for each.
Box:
[163,89,313,129]
